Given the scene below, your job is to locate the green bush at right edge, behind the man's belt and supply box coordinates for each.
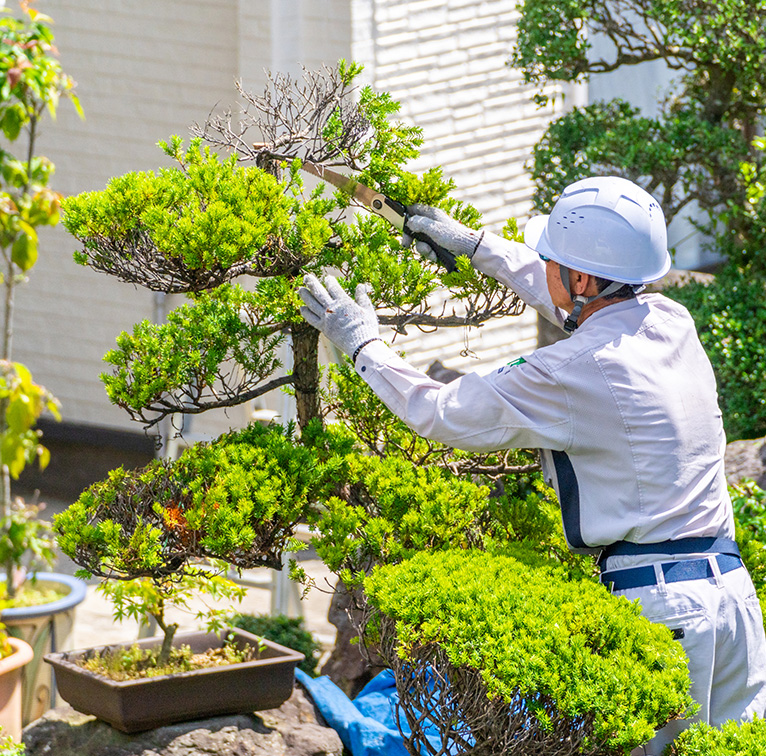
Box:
[729,480,766,618]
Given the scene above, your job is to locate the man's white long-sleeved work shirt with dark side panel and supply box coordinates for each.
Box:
[356,229,734,551]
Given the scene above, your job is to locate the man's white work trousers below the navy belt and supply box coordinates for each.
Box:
[608,557,766,756]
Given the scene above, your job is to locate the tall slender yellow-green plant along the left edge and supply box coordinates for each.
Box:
[0,0,80,599]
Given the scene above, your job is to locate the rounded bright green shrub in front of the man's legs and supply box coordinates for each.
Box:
[364,547,693,755]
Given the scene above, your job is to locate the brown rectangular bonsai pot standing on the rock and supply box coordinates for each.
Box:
[45,629,305,732]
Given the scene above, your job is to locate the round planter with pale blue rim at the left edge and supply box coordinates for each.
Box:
[0,572,87,725]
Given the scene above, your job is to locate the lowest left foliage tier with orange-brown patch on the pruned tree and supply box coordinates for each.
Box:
[54,426,337,579]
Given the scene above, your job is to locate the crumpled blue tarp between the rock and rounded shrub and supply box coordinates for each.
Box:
[295,669,440,756]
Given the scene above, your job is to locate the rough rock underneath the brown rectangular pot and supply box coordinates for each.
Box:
[22,685,343,756]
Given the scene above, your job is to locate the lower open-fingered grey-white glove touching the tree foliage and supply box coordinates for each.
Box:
[298,273,380,362]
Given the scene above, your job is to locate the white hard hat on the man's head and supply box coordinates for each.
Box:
[524,176,670,284]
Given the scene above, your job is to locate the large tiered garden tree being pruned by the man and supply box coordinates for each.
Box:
[54,62,688,752]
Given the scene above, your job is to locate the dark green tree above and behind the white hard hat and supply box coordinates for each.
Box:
[512,0,766,256]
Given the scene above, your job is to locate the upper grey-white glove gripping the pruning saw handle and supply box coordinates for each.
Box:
[402,205,484,273]
